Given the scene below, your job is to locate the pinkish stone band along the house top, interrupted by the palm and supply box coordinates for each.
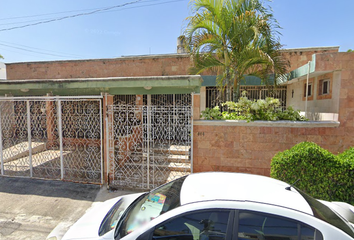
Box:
[6,48,338,80]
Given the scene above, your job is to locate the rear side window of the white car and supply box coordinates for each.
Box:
[238,212,323,240]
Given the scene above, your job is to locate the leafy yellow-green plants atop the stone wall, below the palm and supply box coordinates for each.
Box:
[202,92,307,121]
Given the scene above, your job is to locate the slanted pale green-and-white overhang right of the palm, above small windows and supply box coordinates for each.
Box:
[280,54,336,85]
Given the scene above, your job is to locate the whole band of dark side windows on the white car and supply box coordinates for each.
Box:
[133,209,323,240]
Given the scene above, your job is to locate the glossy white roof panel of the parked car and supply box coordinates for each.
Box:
[180,172,313,215]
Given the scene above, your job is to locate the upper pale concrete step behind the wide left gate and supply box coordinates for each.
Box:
[3,142,46,163]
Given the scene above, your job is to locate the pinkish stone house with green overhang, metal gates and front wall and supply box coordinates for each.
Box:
[0,44,354,189]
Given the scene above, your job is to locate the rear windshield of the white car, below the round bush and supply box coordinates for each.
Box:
[296,188,354,238]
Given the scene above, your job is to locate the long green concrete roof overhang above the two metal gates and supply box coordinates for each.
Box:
[0,75,203,96]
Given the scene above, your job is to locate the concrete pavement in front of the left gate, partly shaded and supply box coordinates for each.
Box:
[0,177,137,240]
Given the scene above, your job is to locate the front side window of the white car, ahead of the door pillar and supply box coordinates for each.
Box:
[153,210,230,240]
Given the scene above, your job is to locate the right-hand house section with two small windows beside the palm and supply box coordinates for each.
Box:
[282,48,342,120]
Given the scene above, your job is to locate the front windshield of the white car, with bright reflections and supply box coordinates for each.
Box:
[115,176,186,239]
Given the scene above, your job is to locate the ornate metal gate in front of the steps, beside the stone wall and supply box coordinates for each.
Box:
[108,94,192,189]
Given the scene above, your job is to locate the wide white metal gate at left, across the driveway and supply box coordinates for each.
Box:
[0,96,103,183]
